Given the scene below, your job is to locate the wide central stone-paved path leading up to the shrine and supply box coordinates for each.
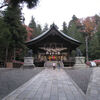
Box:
[2,69,85,100]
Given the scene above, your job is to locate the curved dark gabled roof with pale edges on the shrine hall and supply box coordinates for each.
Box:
[26,24,81,47]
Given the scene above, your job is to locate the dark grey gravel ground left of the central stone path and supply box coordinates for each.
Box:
[0,67,44,100]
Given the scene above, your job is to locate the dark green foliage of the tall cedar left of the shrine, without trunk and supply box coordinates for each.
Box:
[4,6,26,47]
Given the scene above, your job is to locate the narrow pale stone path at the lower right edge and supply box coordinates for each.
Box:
[86,67,100,100]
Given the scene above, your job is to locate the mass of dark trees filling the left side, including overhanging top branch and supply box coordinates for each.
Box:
[0,0,38,61]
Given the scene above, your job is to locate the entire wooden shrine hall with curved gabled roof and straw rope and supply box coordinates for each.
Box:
[26,24,81,66]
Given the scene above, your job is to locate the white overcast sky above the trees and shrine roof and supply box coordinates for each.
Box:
[23,0,100,28]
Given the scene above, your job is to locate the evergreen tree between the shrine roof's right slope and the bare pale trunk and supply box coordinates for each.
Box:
[67,15,85,56]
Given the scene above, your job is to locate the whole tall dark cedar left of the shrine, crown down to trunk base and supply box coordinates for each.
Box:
[4,6,27,60]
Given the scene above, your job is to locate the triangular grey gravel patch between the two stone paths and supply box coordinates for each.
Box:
[64,68,93,93]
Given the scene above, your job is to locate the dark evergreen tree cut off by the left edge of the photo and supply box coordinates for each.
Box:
[0,18,11,61]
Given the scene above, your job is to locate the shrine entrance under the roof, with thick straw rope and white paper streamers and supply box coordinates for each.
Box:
[38,43,68,61]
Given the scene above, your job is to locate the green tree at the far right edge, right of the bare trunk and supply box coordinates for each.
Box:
[89,15,100,60]
